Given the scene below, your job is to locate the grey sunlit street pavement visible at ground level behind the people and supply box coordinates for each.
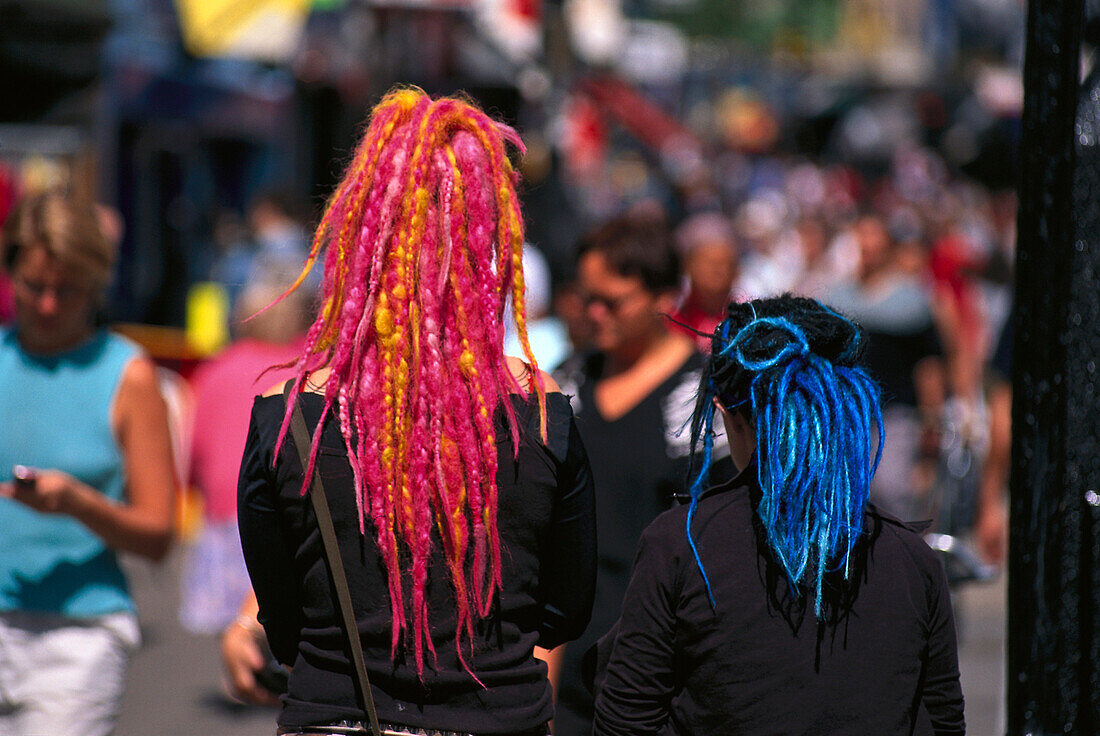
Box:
[116,549,1005,736]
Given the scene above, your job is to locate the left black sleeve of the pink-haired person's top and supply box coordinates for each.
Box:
[237,404,301,664]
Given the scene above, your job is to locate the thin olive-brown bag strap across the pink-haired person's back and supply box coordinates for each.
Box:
[283,381,382,735]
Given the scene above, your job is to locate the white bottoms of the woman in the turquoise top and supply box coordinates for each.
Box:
[0,611,141,736]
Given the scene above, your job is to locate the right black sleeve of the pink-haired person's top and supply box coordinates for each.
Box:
[539,418,596,649]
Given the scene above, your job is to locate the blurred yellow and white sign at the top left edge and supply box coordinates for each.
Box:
[176,0,310,63]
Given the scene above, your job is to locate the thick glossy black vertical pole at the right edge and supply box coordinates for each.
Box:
[1008,0,1100,736]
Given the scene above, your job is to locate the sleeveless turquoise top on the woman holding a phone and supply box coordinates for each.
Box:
[0,328,140,617]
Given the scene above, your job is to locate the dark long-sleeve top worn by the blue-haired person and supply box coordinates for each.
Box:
[594,466,965,736]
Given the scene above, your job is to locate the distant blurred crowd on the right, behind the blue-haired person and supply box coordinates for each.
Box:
[554,139,1015,534]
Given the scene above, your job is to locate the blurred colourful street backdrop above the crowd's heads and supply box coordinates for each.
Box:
[0,0,1023,336]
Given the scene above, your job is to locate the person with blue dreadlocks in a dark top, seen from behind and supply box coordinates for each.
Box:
[594,295,966,736]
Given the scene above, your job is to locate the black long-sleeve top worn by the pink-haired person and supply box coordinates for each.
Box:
[239,393,596,734]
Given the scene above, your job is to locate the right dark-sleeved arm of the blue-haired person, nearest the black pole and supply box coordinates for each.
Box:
[921,554,966,736]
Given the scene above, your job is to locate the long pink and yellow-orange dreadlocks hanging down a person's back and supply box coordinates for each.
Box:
[270,89,546,674]
